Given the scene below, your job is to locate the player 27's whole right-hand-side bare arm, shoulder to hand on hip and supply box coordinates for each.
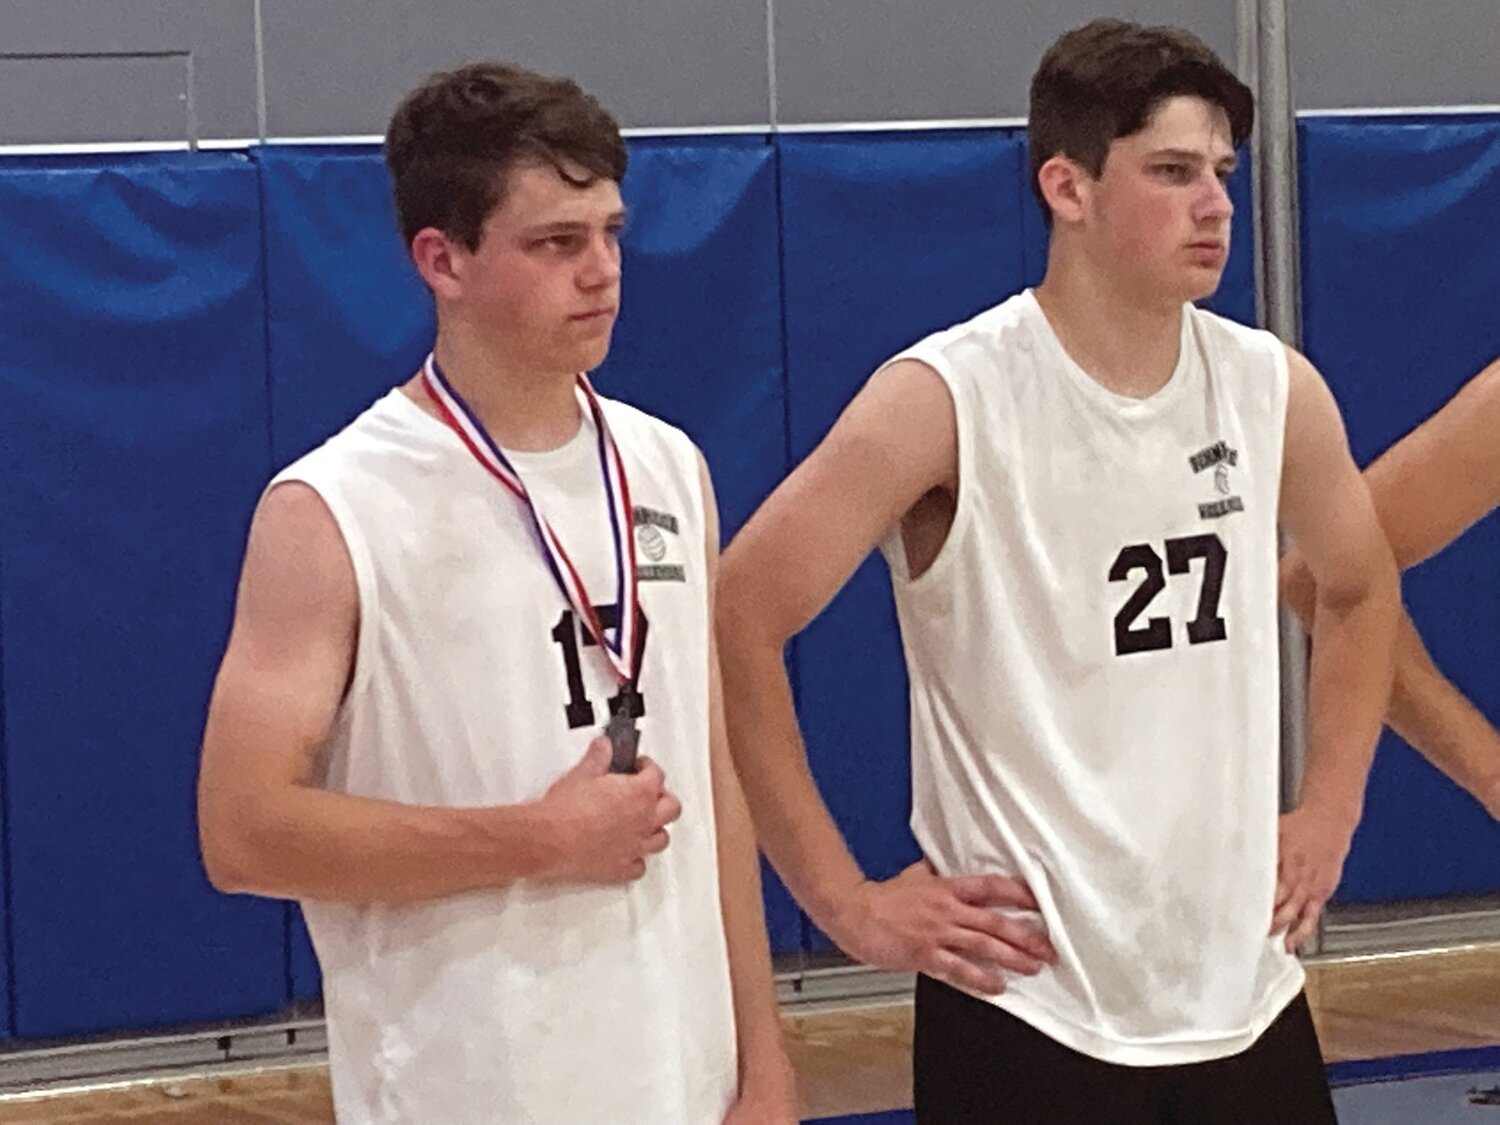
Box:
[1274,350,1400,948]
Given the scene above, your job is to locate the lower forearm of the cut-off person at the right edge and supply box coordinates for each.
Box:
[1386,614,1500,816]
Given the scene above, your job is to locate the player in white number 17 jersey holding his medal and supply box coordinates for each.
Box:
[200,65,795,1125]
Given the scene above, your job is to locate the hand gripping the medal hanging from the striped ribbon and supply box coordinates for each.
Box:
[540,737,683,884]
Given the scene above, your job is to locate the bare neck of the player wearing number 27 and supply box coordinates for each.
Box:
[1035,257,1182,399]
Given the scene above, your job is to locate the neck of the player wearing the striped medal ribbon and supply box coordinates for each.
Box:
[426,326,582,453]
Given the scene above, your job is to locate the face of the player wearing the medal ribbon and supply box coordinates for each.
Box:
[450,164,626,374]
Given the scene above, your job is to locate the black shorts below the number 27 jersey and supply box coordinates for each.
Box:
[912,977,1337,1125]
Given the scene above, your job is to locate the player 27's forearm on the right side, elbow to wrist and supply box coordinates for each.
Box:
[1301,569,1400,831]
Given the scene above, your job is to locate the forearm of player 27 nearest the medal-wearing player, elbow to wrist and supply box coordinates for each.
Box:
[720,639,864,930]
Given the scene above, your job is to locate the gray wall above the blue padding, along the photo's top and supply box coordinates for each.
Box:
[0,0,1500,144]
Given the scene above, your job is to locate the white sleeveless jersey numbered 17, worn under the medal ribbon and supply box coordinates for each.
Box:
[275,392,737,1125]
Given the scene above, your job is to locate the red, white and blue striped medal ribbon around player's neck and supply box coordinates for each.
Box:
[422,356,641,684]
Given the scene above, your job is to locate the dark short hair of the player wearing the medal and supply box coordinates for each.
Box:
[386,63,626,251]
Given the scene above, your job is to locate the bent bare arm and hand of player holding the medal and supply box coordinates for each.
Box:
[198,483,666,903]
